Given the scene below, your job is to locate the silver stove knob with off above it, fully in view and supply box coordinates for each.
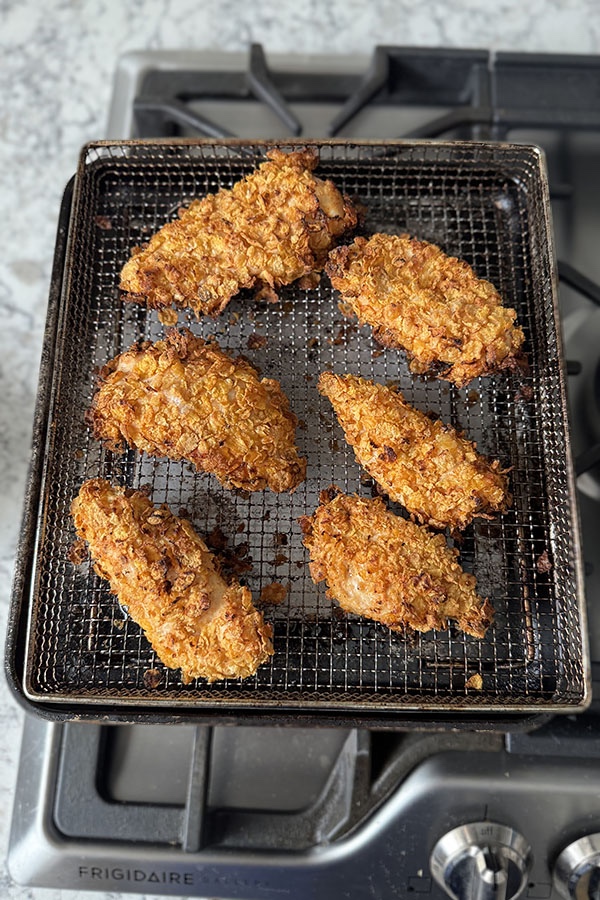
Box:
[430,822,531,900]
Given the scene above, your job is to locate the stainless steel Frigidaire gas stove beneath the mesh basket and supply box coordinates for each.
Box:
[9,46,600,900]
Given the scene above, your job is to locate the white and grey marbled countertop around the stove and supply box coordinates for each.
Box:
[0,0,600,900]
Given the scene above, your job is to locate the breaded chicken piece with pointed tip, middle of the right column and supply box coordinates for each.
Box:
[319,372,511,529]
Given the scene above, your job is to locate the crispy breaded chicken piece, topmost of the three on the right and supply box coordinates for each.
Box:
[325,234,525,387]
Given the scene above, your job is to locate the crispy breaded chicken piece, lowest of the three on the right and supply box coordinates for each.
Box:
[300,492,493,638]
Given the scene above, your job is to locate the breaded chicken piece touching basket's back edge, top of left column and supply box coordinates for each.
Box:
[120,150,357,316]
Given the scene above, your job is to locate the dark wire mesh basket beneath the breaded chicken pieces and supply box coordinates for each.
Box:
[26,142,586,711]
